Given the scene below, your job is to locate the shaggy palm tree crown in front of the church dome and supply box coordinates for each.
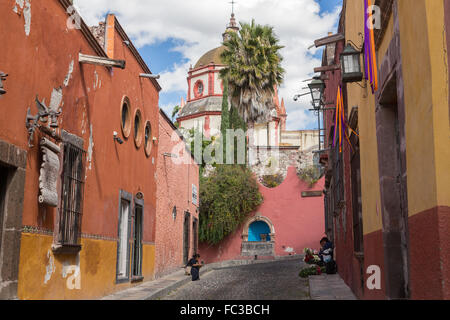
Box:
[220,20,285,125]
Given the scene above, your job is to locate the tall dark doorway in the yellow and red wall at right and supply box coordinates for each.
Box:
[376,73,410,299]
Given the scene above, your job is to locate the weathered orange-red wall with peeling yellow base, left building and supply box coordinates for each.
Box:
[0,0,158,299]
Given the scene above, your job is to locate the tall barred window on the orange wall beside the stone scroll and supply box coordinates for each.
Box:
[57,143,86,249]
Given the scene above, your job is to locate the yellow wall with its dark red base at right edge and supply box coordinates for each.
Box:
[399,1,450,299]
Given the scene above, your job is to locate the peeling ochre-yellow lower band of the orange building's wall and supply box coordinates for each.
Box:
[18,233,155,300]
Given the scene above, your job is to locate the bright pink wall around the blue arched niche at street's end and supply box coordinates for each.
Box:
[199,167,325,263]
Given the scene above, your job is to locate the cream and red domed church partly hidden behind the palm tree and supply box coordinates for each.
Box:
[177,14,319,176]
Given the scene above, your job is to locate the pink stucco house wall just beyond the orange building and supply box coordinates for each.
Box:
[155,113,199,277]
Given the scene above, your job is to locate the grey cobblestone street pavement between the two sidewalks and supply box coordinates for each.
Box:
[161,259,309,300]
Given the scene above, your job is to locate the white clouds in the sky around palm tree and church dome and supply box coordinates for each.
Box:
[75,0,339,130]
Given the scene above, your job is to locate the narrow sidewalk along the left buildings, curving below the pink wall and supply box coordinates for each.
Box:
[100,256,301,300]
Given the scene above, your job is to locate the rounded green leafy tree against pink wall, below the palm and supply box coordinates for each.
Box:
[199,165,263,245]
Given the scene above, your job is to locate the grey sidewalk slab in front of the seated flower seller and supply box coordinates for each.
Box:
[309,274,357,300]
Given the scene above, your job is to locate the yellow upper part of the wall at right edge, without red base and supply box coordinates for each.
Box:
[399,0,450,216]
